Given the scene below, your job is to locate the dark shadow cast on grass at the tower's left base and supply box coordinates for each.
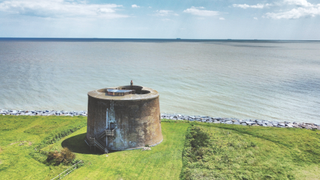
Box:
[61,133,103,155]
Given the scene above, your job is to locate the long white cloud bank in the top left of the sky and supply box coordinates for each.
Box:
[0,0,128,19]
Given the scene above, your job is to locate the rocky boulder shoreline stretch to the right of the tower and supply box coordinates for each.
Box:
[161,114,320,130]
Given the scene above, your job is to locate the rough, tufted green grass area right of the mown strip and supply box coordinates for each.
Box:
[181,123,320,179]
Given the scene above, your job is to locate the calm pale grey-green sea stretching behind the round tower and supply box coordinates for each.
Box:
[0,40,320,123]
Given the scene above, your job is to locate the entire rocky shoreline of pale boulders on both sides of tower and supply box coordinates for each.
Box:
[0,109,320,130]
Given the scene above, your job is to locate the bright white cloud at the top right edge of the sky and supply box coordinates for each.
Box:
[265,4,320,19]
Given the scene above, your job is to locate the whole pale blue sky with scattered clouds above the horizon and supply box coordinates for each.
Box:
[0,0,320,40]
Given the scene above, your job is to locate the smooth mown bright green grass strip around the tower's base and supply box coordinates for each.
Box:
[45,119,189,180]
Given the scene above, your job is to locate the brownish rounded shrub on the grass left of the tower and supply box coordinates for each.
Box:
[46,148,76,165]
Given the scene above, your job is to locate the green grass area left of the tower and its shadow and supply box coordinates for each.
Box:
[0,116,86,179]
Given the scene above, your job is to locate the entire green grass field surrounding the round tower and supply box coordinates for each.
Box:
[0,116,320,180]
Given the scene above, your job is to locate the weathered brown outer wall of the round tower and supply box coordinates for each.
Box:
[87,87,163,151]
